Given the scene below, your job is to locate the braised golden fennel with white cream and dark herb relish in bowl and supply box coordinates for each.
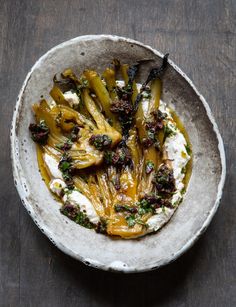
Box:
[29,55,191,239]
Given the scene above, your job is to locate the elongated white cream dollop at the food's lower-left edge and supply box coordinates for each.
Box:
[63,190,100,224]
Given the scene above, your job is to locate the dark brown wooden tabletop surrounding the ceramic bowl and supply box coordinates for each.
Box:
[0,0,236,307]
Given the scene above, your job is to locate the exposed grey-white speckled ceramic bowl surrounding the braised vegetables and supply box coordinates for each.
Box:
[11,35,225,272]
